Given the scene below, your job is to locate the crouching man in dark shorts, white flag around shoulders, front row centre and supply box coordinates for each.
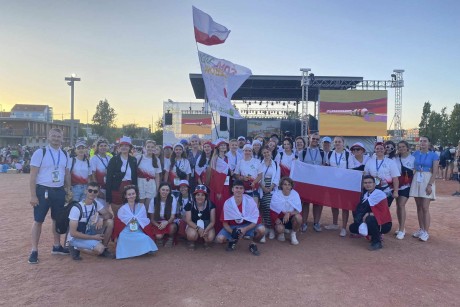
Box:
[216,180,265,256]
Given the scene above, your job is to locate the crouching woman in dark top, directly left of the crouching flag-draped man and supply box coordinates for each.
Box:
[185,184,216,250]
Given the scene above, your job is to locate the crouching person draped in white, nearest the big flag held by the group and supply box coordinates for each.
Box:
[270,177,302,245]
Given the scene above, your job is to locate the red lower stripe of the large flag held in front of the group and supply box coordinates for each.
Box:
[294,181,361,210]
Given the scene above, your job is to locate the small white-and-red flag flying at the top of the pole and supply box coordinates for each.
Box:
[193,7,230,46]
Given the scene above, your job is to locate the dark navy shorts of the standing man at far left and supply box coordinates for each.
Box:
[34,184,65,223]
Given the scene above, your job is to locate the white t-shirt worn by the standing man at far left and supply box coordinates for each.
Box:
[30,146,69,188]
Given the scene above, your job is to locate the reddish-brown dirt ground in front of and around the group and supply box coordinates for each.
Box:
[0,174,460,306]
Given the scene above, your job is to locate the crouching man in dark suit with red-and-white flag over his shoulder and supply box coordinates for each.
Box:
[350,175,392,251]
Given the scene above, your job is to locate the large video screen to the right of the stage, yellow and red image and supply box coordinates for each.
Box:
[319,90,388,136]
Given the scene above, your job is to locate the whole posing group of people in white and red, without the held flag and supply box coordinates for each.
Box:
[29,129,446,263]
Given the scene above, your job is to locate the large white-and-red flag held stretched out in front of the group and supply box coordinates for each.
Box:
[291,160,362,210]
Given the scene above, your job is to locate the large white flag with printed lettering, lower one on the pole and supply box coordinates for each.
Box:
[198,51,252,118]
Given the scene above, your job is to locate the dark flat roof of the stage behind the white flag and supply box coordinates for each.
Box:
[190,74,363,101]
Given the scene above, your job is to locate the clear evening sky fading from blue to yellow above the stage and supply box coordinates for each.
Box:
[0,0,460,128]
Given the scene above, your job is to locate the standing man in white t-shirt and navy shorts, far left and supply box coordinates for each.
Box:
[29,128,70,264]
